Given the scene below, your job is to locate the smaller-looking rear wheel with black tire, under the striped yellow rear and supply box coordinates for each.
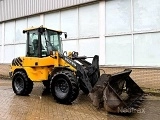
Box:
[12,71,33,96]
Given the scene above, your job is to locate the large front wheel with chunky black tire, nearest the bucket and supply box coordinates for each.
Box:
[50,70,79,104]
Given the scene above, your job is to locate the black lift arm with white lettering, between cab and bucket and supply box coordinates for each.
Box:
[59,53,99,92]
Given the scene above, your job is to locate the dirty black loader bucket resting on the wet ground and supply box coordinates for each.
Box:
[103,70,144,113]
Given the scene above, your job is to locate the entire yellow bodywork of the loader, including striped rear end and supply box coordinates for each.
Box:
[11,55,75,81]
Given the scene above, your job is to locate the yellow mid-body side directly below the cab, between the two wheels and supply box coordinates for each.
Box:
[23,57,58,81]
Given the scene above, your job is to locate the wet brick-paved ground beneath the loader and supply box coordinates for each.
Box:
[0,79,160,120]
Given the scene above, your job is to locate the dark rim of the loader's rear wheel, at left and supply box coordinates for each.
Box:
[14,76,24,91]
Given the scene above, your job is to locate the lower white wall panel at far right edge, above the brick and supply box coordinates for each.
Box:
[134,33,160,66]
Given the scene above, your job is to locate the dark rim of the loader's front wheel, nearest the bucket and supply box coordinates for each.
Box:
[55,78,69,99]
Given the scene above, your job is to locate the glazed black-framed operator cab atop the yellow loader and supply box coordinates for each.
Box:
[23,27,67,57]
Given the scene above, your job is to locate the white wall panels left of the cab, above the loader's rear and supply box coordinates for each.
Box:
[1,19,27,63]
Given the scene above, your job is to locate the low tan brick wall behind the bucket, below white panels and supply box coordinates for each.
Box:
[101,67,160,89]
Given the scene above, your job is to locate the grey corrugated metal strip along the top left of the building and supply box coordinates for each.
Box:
[0,0,97,22]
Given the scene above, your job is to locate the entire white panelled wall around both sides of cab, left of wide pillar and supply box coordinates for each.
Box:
[1,4,99,63]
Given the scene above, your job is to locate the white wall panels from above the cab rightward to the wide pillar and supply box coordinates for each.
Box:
[44,4,99,62]
